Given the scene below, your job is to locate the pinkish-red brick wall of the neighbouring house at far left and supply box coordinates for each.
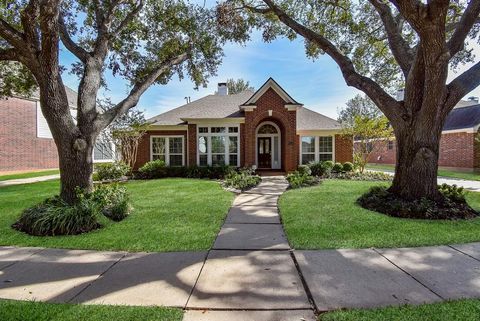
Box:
[0,98,58,171]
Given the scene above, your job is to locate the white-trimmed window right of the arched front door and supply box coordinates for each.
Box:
[300,136,334,165]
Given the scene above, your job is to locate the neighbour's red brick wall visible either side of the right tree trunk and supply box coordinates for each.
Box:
[370,132,480,169]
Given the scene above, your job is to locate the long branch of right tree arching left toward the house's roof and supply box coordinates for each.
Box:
[263,0,403,121]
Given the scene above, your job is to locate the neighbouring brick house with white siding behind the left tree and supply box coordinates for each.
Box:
[0,87,114,171]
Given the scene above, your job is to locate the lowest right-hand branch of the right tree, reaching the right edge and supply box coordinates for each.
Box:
[445,62,480,112]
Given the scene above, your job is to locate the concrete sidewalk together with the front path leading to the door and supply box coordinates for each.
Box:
[0,177,480,321]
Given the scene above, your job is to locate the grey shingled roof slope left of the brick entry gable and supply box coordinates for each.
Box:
[148,90,253,125]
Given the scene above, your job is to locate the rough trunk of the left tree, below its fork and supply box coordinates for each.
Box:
[57,139,93,204]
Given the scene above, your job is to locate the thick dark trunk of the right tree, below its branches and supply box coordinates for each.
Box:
[389,124,442,200]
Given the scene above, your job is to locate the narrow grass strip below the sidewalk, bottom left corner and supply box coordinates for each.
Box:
[0,300,183,321]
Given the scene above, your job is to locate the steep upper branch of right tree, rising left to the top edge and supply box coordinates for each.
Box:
[369,0,413,78]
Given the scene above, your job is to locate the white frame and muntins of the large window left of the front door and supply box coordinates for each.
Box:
[196,124,240,167]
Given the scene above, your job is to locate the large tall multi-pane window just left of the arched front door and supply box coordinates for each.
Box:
[197,125,240,167]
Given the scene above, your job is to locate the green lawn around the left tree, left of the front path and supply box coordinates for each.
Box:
[0,179,233,252]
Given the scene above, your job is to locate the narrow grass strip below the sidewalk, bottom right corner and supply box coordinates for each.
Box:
[318,300,480,321]
